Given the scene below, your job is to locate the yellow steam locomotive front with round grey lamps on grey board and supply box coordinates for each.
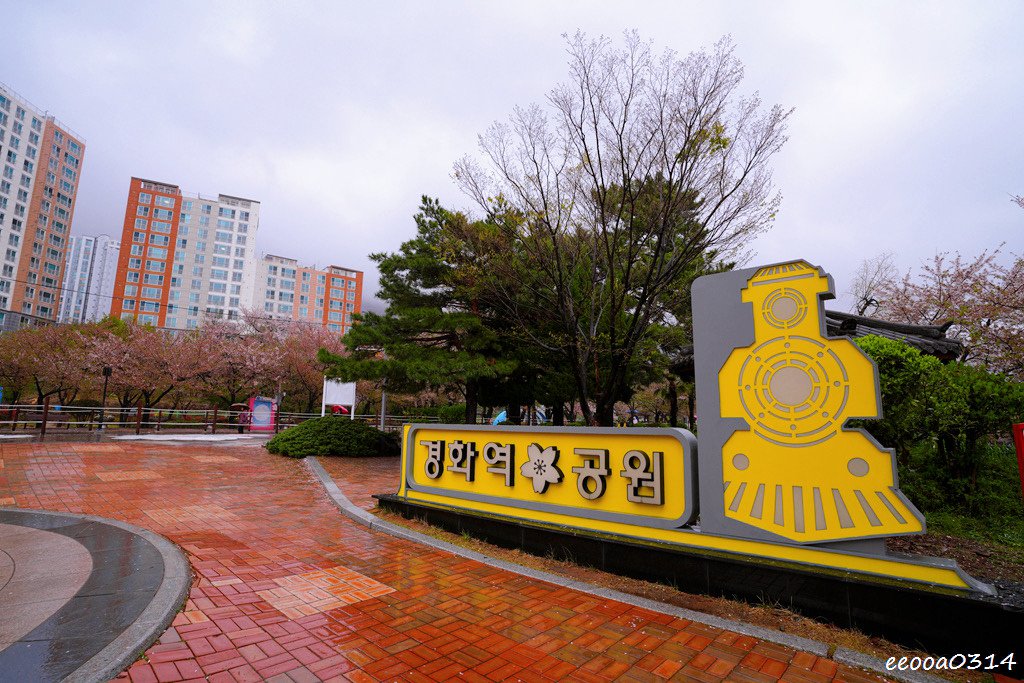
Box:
[705,261,923,543]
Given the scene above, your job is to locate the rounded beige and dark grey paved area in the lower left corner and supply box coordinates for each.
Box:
[0,509,188,681]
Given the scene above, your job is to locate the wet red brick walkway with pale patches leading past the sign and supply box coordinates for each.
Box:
[0,443,879,683]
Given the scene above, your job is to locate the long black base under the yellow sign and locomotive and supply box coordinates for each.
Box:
[374,495,1024,659]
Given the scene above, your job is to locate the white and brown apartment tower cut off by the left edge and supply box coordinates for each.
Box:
[0,84,85,330]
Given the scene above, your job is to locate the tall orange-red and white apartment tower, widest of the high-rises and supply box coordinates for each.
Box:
[110,178,260,330]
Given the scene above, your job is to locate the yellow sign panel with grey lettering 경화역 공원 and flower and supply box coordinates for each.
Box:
[401,425,696,530]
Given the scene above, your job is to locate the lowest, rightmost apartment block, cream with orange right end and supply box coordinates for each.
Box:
[253,254,362,333]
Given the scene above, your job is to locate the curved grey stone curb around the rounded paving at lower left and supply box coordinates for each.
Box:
[1,508,191,683]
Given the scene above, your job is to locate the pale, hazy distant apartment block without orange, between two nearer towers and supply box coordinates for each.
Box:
[57,234,121,323]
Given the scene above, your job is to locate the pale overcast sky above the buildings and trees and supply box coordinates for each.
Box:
[0,0,1024,309]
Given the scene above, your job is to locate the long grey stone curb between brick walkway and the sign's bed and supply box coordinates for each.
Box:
[305,457,913,667]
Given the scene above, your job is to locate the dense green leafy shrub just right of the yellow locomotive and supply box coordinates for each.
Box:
[851,337,1024,546]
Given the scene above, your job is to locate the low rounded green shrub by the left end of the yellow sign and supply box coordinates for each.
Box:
[266,416,401,458]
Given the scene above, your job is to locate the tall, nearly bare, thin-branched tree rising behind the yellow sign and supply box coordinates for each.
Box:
[455,32,790,424]
